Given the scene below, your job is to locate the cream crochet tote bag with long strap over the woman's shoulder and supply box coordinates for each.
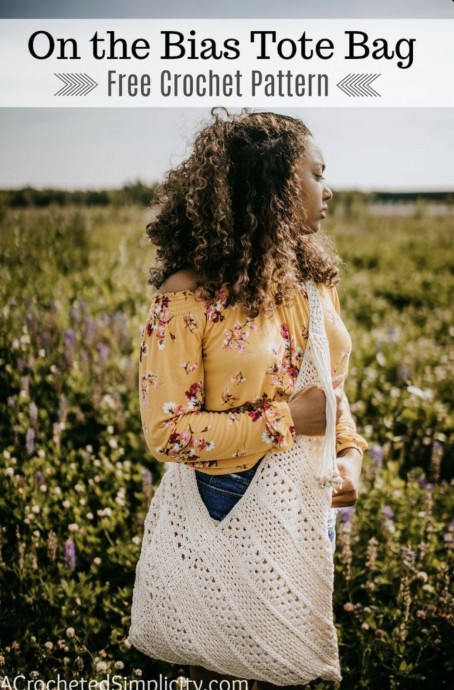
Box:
[129,282,342,685]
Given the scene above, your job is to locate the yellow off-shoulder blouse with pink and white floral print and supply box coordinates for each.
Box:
[139,287,368,474]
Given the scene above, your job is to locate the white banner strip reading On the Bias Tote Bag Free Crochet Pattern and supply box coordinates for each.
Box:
[0,19,454,108]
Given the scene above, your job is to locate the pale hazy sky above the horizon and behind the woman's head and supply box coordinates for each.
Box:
[0,0,454,191]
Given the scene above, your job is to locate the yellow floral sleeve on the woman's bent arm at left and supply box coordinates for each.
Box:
[139,293,294,467]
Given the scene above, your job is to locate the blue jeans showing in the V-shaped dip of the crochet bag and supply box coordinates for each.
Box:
[194,460,339,553]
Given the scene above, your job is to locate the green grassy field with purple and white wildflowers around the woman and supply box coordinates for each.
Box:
[0,206,454,690]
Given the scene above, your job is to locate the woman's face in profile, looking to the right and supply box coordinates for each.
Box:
[297,137,333,233]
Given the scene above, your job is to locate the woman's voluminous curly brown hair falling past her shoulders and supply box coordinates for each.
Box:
[147,108,339,315]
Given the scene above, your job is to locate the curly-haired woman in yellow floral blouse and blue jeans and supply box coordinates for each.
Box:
[131,110,367,690]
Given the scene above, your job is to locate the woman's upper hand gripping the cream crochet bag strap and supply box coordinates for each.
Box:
[289,386,345,436]
